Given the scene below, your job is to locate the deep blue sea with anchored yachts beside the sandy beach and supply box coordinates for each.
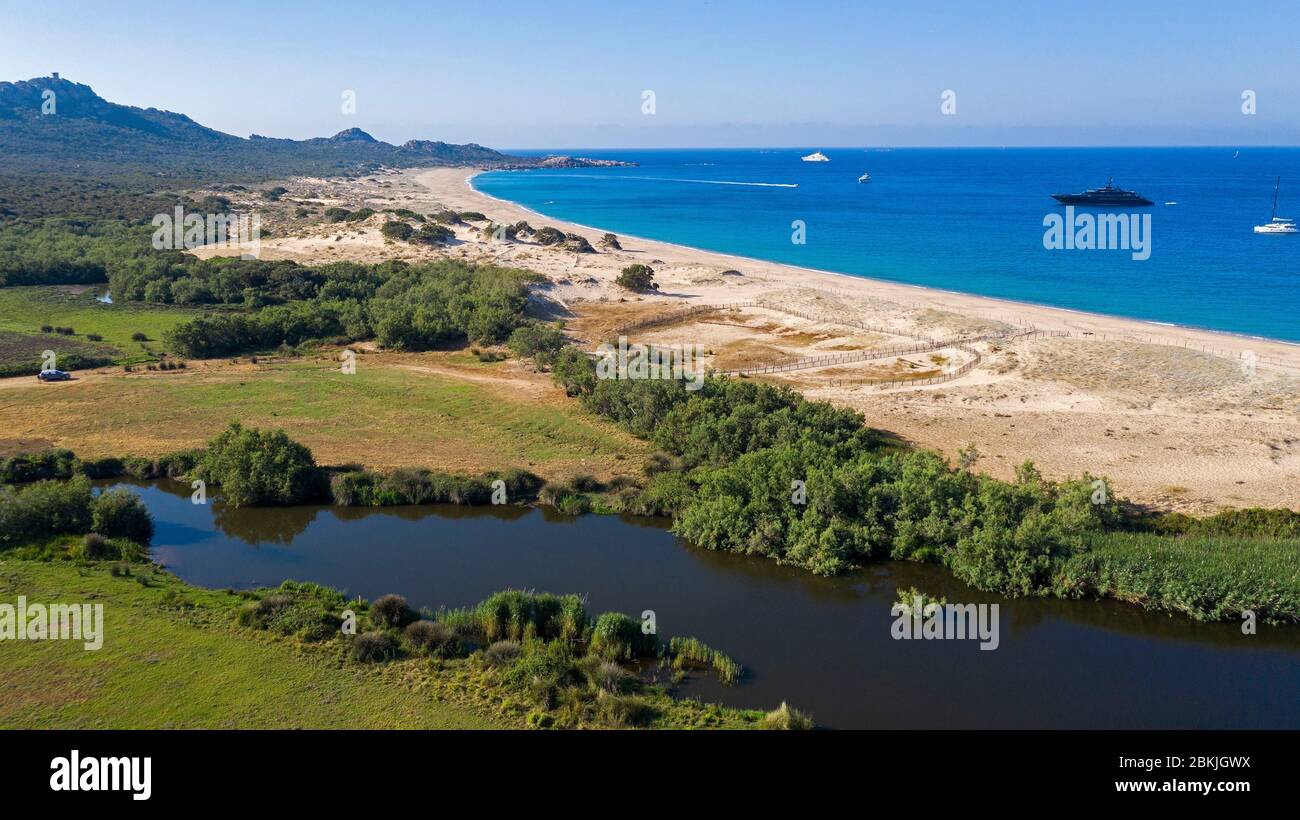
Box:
[475,148,1300,342]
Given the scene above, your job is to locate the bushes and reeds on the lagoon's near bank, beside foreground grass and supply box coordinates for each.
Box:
[238,582,759,728]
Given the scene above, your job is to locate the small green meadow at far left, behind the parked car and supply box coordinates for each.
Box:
[0,287,202,359]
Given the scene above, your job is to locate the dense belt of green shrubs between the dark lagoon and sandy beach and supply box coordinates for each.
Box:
[553,351,1300,621]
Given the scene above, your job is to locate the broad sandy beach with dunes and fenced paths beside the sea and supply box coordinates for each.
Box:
[189,168,1300,512]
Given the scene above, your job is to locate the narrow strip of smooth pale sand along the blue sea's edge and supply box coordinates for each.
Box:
[439,166,1300,369]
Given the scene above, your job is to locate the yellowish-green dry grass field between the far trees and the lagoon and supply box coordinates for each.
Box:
[0,353,647,477]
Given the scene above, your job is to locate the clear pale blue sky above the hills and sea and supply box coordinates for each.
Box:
[0,0,1300,148]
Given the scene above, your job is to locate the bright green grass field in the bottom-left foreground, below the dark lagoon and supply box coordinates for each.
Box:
[0,559,504,729]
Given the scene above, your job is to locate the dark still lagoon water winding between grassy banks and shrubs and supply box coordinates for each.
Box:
[114,481,1300,729]
